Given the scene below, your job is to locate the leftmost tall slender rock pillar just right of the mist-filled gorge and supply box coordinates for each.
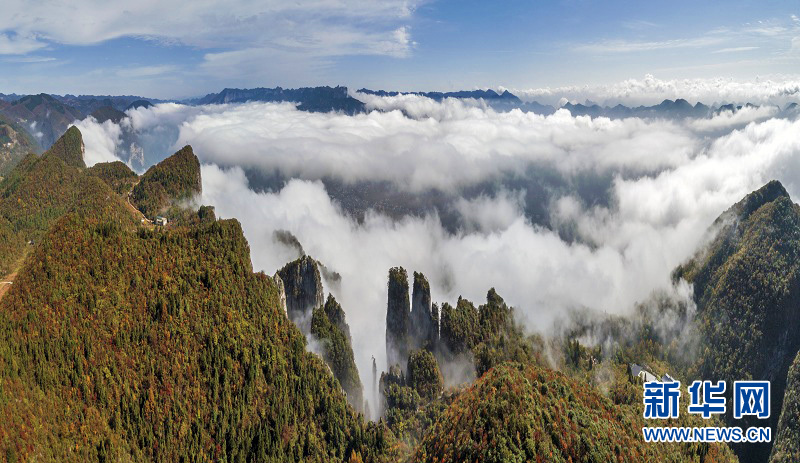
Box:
[386,267,411,366]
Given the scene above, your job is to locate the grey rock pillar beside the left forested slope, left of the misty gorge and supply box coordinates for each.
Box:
[278,256,325,328]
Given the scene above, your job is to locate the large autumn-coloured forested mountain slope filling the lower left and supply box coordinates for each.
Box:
[0,129,390,462]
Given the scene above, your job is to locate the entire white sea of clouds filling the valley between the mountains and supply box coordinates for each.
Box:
[77,86,800,414]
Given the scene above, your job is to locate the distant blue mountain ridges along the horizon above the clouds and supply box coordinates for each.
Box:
[0,86,800,160]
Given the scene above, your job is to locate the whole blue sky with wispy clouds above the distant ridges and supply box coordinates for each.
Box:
[0,0,800,98]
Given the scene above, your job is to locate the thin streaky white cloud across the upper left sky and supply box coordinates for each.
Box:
[0,0,423,76]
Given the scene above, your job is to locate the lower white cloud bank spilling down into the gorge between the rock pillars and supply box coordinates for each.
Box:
[194,112,800,398]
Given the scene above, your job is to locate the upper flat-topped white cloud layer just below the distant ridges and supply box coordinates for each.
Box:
[109,95,695,192]
